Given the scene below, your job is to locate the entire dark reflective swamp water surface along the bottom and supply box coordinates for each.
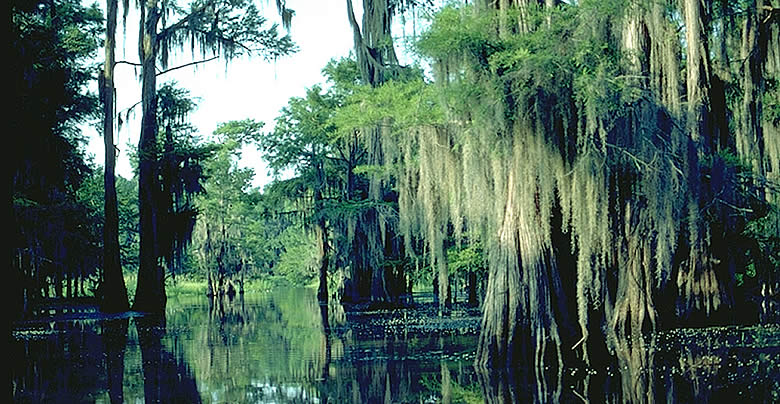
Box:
[9,289,780,404]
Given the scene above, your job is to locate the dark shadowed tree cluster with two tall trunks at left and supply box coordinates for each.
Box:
[9,0,295,313]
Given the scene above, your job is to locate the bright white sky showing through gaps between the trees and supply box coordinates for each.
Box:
[87,0,361,186]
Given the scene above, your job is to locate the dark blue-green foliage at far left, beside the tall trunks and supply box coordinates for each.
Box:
[12,0,102,306]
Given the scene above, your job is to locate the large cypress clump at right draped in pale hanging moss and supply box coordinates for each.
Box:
[383,0,777,368]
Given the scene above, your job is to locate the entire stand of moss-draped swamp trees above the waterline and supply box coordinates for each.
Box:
[12,0,780,386]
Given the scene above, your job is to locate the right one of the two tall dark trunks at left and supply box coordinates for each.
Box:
[133,0,166,313]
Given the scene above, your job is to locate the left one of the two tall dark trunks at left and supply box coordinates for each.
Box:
[100,0,128,312]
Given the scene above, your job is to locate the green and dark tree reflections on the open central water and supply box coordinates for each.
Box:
[169,289,478,403]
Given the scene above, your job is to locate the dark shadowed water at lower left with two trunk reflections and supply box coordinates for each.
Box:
[11,317,200,403]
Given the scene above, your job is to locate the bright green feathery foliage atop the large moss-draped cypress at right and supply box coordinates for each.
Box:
[417,0,639,134]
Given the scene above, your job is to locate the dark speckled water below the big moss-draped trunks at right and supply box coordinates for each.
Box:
[476,327,780,404]
